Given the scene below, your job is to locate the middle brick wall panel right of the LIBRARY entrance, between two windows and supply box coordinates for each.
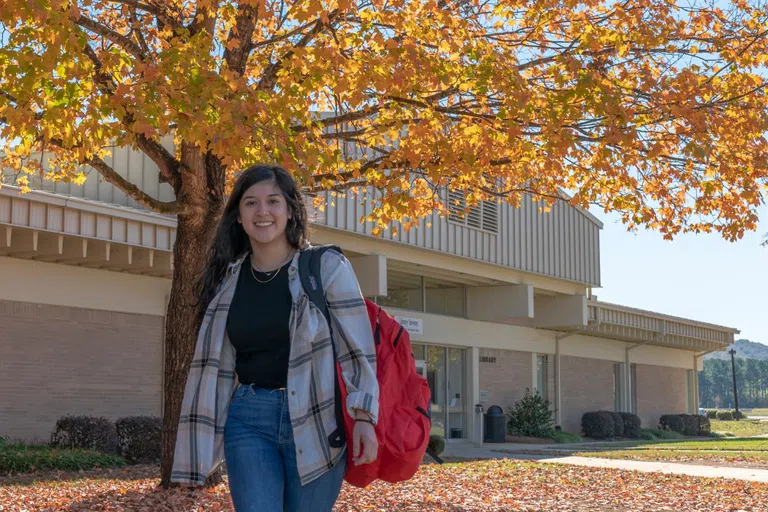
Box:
[560,356,616,434]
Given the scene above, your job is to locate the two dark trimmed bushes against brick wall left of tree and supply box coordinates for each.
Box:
[51,416,163,463]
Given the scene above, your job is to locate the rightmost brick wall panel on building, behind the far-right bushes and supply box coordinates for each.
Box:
[635,364,688,428]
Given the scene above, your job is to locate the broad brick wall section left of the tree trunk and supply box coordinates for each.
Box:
[0,300,163,440]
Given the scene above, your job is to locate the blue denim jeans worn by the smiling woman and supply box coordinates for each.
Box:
[224,385,346,512]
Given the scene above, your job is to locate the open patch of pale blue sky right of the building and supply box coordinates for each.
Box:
[592,206,768,344]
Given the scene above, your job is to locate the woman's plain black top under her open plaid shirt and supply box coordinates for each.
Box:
[227,259,292,389]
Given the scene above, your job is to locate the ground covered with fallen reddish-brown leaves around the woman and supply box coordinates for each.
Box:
[0,460,768,512]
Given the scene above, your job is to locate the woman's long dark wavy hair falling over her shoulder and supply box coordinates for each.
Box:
[198,165,307,318]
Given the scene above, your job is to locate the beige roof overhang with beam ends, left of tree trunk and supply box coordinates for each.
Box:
[0,185,176,278]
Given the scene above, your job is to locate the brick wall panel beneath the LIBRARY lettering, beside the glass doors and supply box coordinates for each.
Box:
[479,349,533,414]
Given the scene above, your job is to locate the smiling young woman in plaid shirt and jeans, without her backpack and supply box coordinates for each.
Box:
[171,165,379,512]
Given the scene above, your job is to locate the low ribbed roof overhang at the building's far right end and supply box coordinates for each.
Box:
[557,300,739,352]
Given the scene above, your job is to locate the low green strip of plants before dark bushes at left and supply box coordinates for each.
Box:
[0,444,125,474]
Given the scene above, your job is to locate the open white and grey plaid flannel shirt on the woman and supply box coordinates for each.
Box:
[171,247,379,485]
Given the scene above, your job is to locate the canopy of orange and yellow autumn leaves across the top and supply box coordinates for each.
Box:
[0,0,768,240]
